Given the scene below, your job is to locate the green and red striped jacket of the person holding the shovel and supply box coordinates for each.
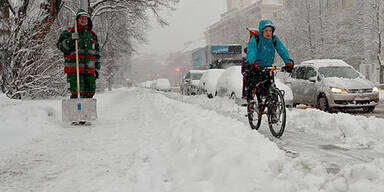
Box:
[57,26,100,74]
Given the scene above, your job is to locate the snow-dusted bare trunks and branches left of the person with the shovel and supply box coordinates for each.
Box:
[0,0,61,99]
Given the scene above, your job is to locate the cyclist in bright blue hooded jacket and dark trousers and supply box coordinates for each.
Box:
[245,20,293,112]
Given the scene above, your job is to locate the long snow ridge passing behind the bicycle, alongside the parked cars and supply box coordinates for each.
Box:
[172,91,384,150]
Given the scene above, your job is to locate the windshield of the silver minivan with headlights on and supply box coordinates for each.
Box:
[319,66,360,79]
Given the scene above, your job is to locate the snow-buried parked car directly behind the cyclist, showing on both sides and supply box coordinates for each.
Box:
[216,66,293,106]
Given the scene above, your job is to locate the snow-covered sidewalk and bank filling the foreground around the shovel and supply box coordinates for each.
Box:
[0,89,384,192]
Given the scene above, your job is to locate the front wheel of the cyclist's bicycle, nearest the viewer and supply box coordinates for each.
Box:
[267,88,286,138]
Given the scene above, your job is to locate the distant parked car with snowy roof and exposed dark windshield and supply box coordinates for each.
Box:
[181,70,206,95]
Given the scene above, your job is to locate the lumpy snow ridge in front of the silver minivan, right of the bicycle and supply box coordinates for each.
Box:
[287,109,384,149]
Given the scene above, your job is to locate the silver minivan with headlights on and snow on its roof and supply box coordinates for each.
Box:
[287,59,379,112]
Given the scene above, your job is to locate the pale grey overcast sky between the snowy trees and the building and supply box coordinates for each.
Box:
[140,0,226,54]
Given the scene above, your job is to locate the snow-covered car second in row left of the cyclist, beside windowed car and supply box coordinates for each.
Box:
[198,69,225,98]
